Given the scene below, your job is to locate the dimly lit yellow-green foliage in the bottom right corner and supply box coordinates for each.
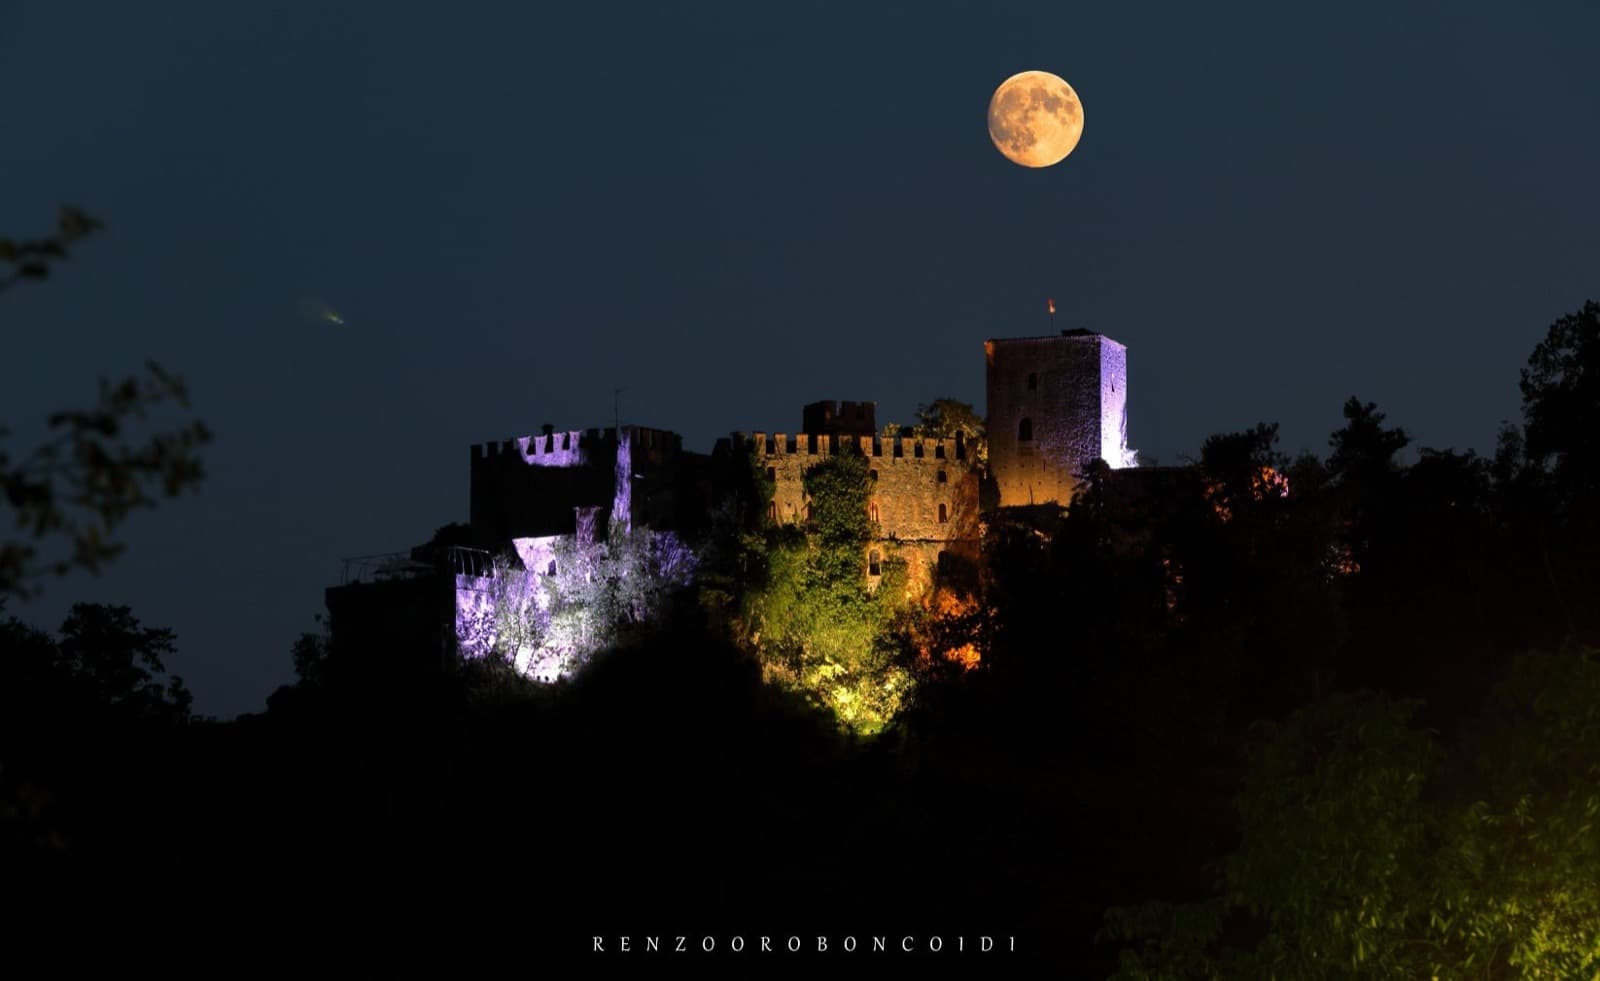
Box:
[1107,651,1600,978]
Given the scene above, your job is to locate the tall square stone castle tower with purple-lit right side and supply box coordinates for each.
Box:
[984,330,1134,507]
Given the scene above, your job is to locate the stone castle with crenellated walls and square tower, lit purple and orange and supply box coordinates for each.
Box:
[326,330,1134,666]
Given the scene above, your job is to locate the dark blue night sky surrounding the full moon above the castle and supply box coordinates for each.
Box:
[0,0,1600,717]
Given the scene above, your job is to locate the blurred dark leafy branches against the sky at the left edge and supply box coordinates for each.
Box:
[0,208,211,597]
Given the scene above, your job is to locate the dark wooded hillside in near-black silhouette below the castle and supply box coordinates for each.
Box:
[9,302,1600,978]
